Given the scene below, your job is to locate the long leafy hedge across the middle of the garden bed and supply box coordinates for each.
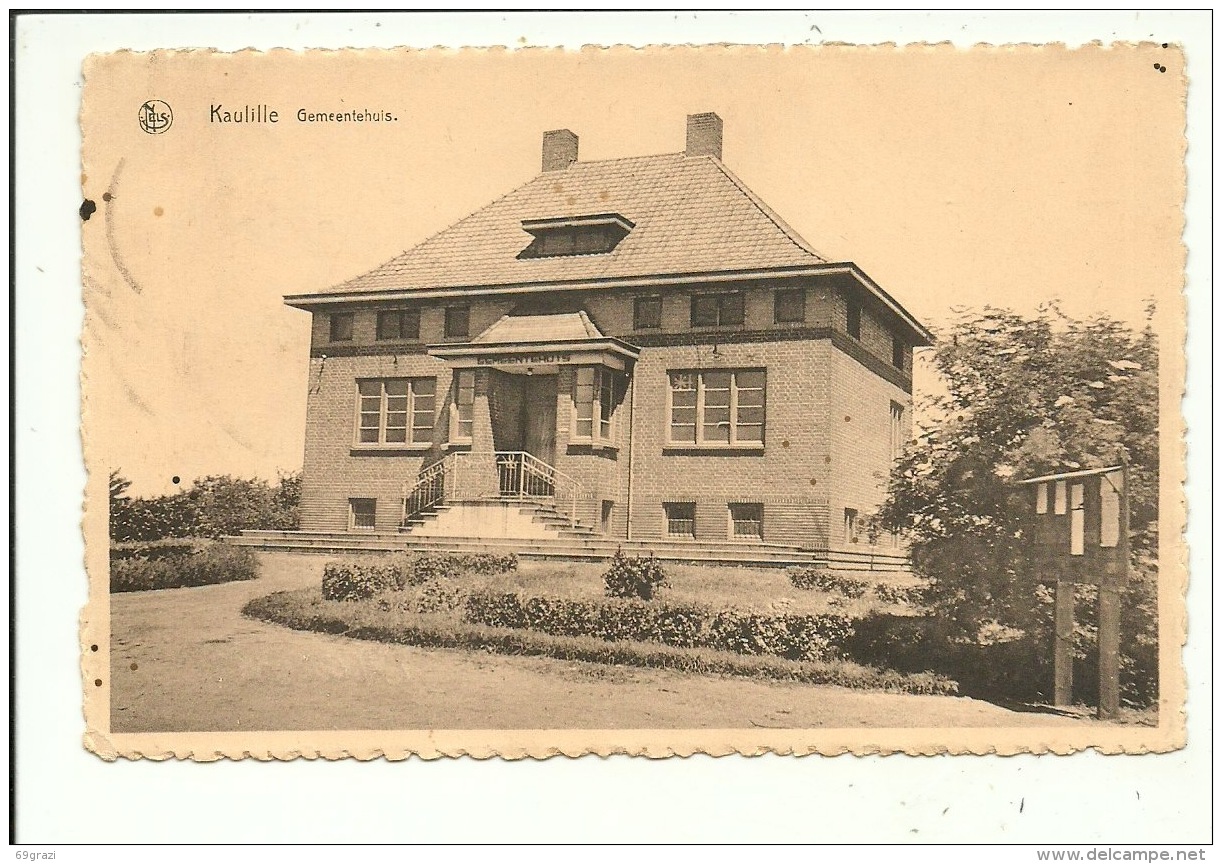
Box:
[463,591,853,660]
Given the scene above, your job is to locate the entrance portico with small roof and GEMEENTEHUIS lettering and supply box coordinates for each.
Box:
[404,310,639,523]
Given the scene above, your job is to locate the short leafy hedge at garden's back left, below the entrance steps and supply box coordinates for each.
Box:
[323,552,518,600]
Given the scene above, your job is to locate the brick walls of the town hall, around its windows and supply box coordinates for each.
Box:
[302,280,912,547]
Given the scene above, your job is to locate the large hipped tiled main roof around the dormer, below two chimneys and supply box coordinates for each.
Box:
[317,154,826,300]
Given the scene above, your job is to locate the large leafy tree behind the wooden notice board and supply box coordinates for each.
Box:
[877,306,1158,697]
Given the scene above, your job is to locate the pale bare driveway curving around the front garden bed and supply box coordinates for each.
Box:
[111,552,1081,732]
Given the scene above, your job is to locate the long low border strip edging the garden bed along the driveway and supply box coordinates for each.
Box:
[242,589,958,695]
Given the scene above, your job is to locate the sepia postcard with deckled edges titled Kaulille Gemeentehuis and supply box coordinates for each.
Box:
[81,43,1182,760]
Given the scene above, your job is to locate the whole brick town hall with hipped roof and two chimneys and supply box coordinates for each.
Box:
[265,114,931,563]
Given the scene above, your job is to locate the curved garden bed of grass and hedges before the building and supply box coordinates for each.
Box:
[243,557,956,693]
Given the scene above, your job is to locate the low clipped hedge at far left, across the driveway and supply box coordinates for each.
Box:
[110,544,259,593]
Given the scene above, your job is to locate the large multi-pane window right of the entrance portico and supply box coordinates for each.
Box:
[670,369,765,446]
